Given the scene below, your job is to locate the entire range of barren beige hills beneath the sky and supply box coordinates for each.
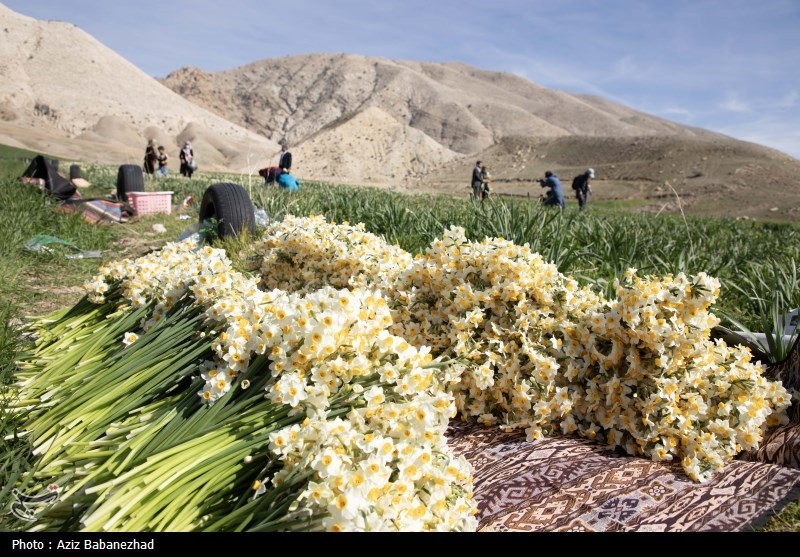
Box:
[0,5,800,220]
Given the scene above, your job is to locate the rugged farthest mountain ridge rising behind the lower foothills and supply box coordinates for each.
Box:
[164,54,715,154]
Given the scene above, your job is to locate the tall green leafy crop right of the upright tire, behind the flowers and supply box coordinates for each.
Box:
[239,180,800,330]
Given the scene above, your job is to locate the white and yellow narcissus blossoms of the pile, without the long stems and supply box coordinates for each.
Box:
[81,210,790,530]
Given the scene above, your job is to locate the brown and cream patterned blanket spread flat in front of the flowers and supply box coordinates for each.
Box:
[448,422,800,532]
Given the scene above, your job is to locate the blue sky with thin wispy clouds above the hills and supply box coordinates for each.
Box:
[2,0,800,159]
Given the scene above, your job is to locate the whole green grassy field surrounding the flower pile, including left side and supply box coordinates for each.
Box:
[0,144,800,531]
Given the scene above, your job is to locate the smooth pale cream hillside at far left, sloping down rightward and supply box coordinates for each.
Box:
[0,4,277,172]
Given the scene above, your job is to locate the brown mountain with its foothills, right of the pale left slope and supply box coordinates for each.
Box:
[163,54,800,220]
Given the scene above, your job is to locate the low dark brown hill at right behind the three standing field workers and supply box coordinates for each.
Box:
[418,136,800,221]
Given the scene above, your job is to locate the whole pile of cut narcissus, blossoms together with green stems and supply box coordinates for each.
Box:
[6,216,791,531]
